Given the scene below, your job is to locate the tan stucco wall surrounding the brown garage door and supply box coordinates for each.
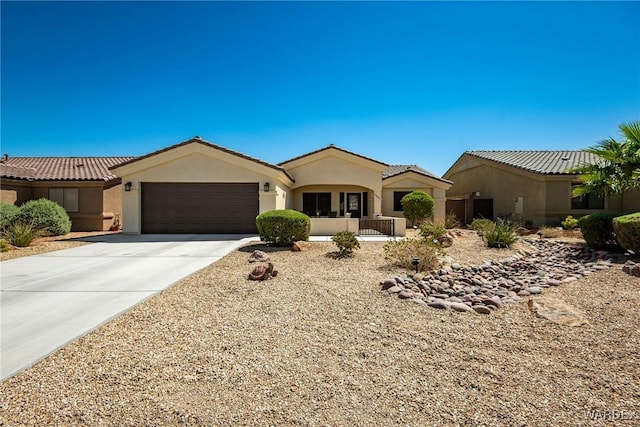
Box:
[114,143,290,234]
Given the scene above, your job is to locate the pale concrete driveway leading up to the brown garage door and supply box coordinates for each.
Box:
[0,234,257,380]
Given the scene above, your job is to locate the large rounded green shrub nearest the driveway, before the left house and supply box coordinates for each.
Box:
[15,199,71,236]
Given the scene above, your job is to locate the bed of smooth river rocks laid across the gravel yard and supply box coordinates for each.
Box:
[380,239,617,314]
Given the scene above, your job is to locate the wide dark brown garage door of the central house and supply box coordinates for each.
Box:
[142,182,259,234]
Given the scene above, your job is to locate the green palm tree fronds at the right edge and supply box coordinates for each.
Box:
[571,121,640,196]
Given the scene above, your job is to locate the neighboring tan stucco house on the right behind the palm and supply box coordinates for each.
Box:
[443,151,640,226]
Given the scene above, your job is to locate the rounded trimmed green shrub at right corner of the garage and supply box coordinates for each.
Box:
[256,209,311,246]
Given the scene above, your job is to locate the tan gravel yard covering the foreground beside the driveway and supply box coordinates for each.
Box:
[0,232,640,426]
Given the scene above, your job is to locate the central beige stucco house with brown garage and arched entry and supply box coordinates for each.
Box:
[111,137,451,233]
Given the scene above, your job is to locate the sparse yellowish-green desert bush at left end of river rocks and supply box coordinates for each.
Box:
[384,238,444,271]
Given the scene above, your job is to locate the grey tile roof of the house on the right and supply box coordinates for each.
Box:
[464,150,600,175]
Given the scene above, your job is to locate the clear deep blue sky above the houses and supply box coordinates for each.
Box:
[1,1,640,175]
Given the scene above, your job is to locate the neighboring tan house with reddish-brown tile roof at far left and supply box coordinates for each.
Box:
[0,156,131,231]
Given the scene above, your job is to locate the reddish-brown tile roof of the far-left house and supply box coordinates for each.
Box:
[0,157,134,181]
